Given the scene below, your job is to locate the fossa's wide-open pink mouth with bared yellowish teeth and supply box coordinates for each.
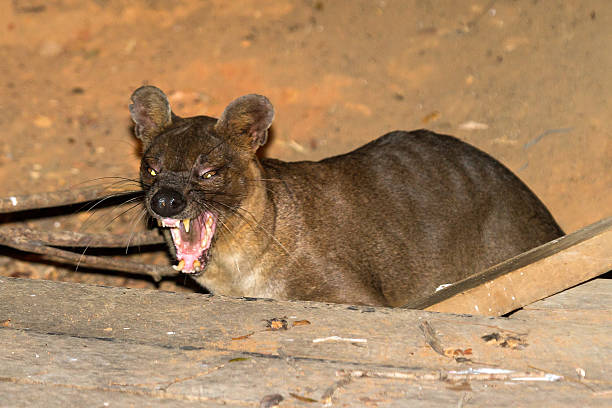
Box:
[161,211,217,273]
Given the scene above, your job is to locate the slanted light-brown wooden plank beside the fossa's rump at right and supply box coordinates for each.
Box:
[404,217,612,316]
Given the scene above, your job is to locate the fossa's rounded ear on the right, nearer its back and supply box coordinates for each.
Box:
[215,94,274,151]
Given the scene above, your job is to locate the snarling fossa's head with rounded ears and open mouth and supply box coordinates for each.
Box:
[130,86,274,273]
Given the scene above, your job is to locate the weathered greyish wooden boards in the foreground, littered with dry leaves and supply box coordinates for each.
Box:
[0,278,612,407]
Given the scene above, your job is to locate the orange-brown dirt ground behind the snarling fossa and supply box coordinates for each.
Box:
[0,0,612,290]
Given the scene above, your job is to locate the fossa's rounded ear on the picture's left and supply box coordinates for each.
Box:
[130,85,172,148]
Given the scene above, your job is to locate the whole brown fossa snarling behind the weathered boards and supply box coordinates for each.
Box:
[130,87,563,306]
